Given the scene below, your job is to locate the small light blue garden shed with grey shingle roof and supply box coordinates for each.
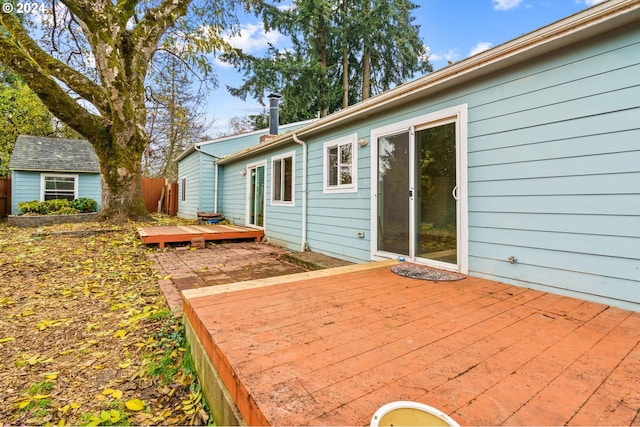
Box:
[9,135,102,215]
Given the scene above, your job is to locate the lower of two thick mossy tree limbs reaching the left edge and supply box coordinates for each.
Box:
[0,31,108,143]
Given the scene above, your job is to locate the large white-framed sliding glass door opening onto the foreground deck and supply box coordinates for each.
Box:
[372,110,466,271]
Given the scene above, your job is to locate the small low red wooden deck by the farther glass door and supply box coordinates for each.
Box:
[138,225,264,248]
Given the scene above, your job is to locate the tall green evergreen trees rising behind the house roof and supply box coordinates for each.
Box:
[223,0,431,122]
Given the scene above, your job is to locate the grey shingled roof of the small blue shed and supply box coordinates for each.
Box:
[9,135,100,173]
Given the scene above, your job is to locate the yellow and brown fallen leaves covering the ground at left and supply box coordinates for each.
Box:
[0,216,214,425]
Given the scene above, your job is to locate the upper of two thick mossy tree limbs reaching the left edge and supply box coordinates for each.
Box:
[0,13,110,116]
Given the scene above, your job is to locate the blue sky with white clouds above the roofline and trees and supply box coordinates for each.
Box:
[207,0,602,136]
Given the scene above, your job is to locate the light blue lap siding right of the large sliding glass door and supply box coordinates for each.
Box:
[468,23,640,309]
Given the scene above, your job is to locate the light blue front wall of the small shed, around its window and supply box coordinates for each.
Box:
[11,170,102,215]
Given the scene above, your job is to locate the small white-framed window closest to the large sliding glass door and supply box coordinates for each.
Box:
[324,134,358,193]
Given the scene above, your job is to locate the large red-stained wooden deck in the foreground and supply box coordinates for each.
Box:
[183,262,640,425]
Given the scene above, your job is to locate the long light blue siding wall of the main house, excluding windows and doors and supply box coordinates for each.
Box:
[218,21,640,310]
